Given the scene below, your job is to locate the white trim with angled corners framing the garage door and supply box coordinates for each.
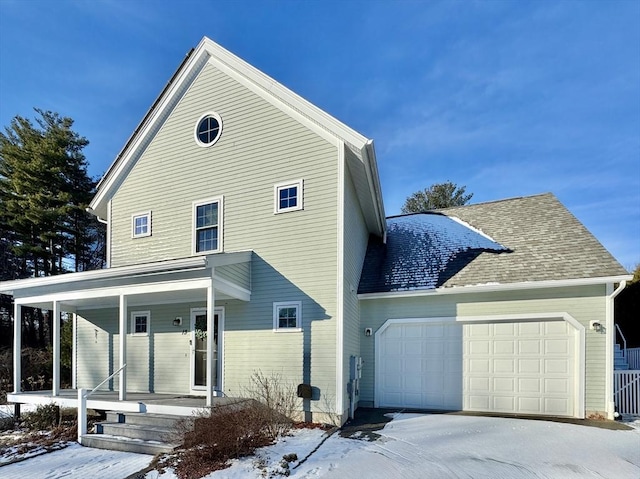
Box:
[374,312,585,418]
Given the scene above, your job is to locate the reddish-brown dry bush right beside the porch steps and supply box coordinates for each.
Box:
[174,401,274,479]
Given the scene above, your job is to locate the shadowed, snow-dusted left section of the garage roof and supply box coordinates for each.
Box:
[358,213,510,293]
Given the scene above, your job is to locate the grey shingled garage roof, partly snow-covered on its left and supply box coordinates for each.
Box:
[359,193,628,293]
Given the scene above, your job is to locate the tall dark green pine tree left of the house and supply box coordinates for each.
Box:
[0,109,103,277]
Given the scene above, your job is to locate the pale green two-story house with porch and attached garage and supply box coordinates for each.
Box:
[0,38,630,423]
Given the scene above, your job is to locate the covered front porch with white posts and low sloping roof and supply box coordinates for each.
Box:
[0,255,252,412]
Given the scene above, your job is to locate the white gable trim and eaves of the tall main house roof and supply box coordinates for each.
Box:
[89,37,385,235]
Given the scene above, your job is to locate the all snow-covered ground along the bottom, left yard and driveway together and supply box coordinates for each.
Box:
[0,414,640,479]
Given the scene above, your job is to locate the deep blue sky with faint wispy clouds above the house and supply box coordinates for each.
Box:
[0,0,640,269]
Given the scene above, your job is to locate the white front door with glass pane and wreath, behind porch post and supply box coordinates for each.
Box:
[190,308,224,391]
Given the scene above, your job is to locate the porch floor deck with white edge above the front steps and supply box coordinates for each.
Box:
[7,389,238,416]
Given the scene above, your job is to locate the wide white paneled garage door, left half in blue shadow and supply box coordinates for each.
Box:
[376,320,577,416]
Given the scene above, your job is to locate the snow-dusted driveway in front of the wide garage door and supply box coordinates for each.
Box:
[291,414,640,479]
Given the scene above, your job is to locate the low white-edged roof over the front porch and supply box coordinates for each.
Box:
[0,251,252,312]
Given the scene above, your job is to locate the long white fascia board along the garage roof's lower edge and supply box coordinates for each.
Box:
[358,275,633,300]
